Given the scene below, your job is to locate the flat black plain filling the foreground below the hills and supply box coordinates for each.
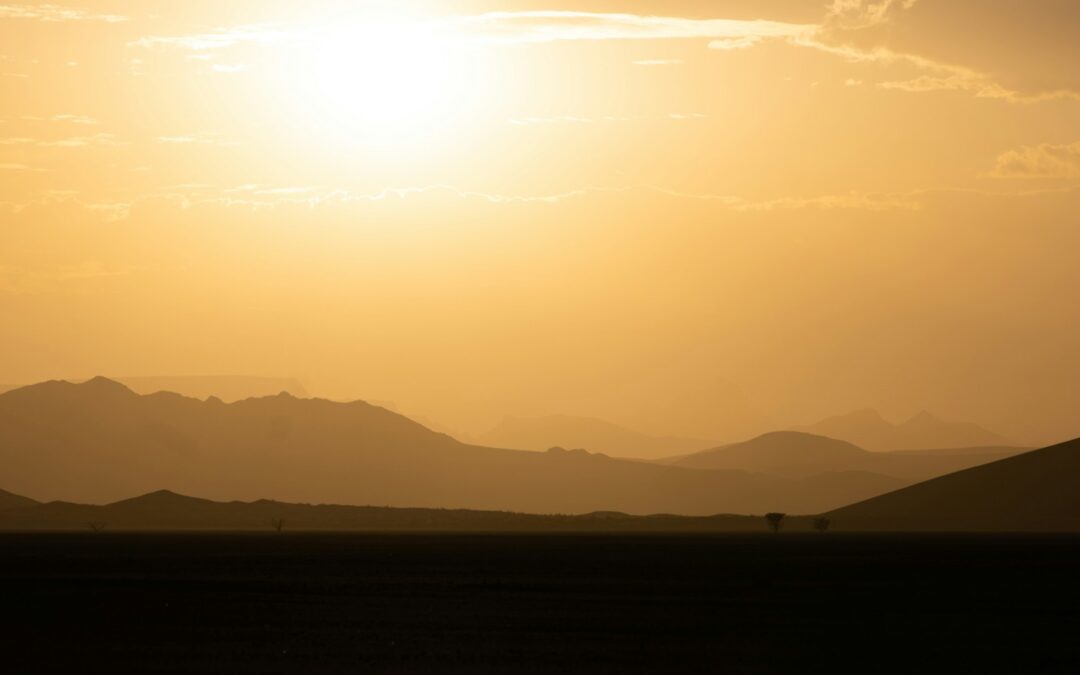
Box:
[0,532,1080,673]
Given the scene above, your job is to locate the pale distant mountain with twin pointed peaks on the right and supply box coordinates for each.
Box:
[793,408,1020,451]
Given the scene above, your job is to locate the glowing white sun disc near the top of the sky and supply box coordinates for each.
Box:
[282,16,472,145]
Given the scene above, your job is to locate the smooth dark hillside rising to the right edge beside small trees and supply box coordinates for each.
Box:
[829,440,1080,531]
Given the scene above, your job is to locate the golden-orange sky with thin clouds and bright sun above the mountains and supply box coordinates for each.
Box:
[0,0,1080,443]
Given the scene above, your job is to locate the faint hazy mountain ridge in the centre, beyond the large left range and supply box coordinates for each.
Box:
[476,415,712,459]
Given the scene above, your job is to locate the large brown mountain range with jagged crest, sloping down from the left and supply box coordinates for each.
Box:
[0,378,894,515]
